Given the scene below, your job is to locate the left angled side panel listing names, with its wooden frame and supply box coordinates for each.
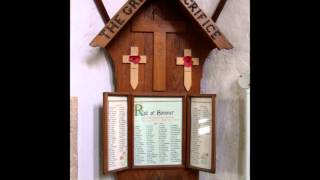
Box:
[104,93,129,173]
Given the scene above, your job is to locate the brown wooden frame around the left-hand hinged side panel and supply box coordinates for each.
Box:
[103,92,131,174]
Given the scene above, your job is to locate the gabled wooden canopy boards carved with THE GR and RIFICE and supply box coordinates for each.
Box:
[90,0,233,49]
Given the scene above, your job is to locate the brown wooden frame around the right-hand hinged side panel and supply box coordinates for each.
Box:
[186,94,216,173]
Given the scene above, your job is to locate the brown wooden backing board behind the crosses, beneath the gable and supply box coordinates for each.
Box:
[107,3,212,93]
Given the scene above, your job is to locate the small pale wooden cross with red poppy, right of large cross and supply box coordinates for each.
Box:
[177,49,199,91]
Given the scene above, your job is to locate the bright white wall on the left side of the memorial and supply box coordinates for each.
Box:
[70,0,124,180]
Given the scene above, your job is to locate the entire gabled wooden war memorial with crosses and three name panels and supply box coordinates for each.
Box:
[90,0,233,180]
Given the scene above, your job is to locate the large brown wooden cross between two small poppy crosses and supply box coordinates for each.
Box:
[132,16,186,91]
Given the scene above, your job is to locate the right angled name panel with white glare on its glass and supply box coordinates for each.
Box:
[187,95,215,173]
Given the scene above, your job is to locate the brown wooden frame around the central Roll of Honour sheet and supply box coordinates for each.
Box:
[130,92,186,169]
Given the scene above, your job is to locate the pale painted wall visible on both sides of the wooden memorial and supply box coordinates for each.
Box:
[70,0,250,180]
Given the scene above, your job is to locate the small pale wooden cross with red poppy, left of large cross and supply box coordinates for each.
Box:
[122,47,147,89]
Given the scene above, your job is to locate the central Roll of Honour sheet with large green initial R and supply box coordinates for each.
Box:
[132,95,185,168]
